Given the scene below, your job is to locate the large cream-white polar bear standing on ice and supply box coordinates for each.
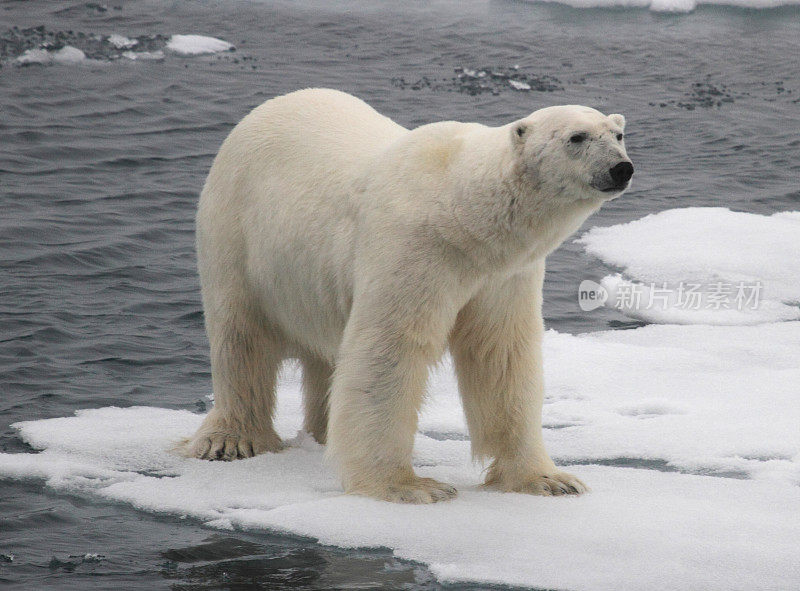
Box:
[183,89,633,503]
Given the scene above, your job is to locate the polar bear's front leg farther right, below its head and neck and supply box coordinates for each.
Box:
[450,261,586,495]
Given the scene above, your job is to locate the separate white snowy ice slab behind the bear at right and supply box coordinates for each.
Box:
[577,207,800,324]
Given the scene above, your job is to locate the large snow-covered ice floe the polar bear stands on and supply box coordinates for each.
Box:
[0,322,800,591]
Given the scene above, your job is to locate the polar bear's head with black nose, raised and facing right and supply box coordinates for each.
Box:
[510,105,633,199]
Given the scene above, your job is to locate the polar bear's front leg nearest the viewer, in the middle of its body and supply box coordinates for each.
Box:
[328,286,456,503]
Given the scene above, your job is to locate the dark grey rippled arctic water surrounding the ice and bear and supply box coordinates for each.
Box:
[0,0,800,589]
